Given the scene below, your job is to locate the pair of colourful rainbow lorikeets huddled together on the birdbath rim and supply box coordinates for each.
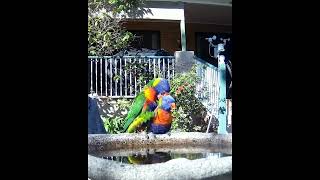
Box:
[122,78,175,134]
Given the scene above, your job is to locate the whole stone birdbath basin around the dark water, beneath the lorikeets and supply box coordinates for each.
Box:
[88,132,232,180]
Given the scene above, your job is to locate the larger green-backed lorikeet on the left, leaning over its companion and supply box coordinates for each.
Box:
[122,78,170,133]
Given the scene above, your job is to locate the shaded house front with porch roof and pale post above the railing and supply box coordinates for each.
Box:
[124,0,232,59]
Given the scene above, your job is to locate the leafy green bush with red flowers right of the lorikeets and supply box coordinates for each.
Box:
[170,65,207,132]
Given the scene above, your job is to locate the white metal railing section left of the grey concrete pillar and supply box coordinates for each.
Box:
[88,56,175,98]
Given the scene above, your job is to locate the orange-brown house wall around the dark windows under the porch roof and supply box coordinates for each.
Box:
[124,20,232,54]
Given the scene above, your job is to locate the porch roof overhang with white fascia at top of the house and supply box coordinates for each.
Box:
[125,0,232,26]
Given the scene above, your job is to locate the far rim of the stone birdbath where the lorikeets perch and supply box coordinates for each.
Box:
[88,132,232,150]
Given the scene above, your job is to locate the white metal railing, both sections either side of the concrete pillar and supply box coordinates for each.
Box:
[88,56,219,117]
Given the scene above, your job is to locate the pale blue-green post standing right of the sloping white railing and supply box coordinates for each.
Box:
[218,55,228,134]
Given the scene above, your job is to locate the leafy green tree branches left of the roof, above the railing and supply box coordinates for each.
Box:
[88,0,144,56]
